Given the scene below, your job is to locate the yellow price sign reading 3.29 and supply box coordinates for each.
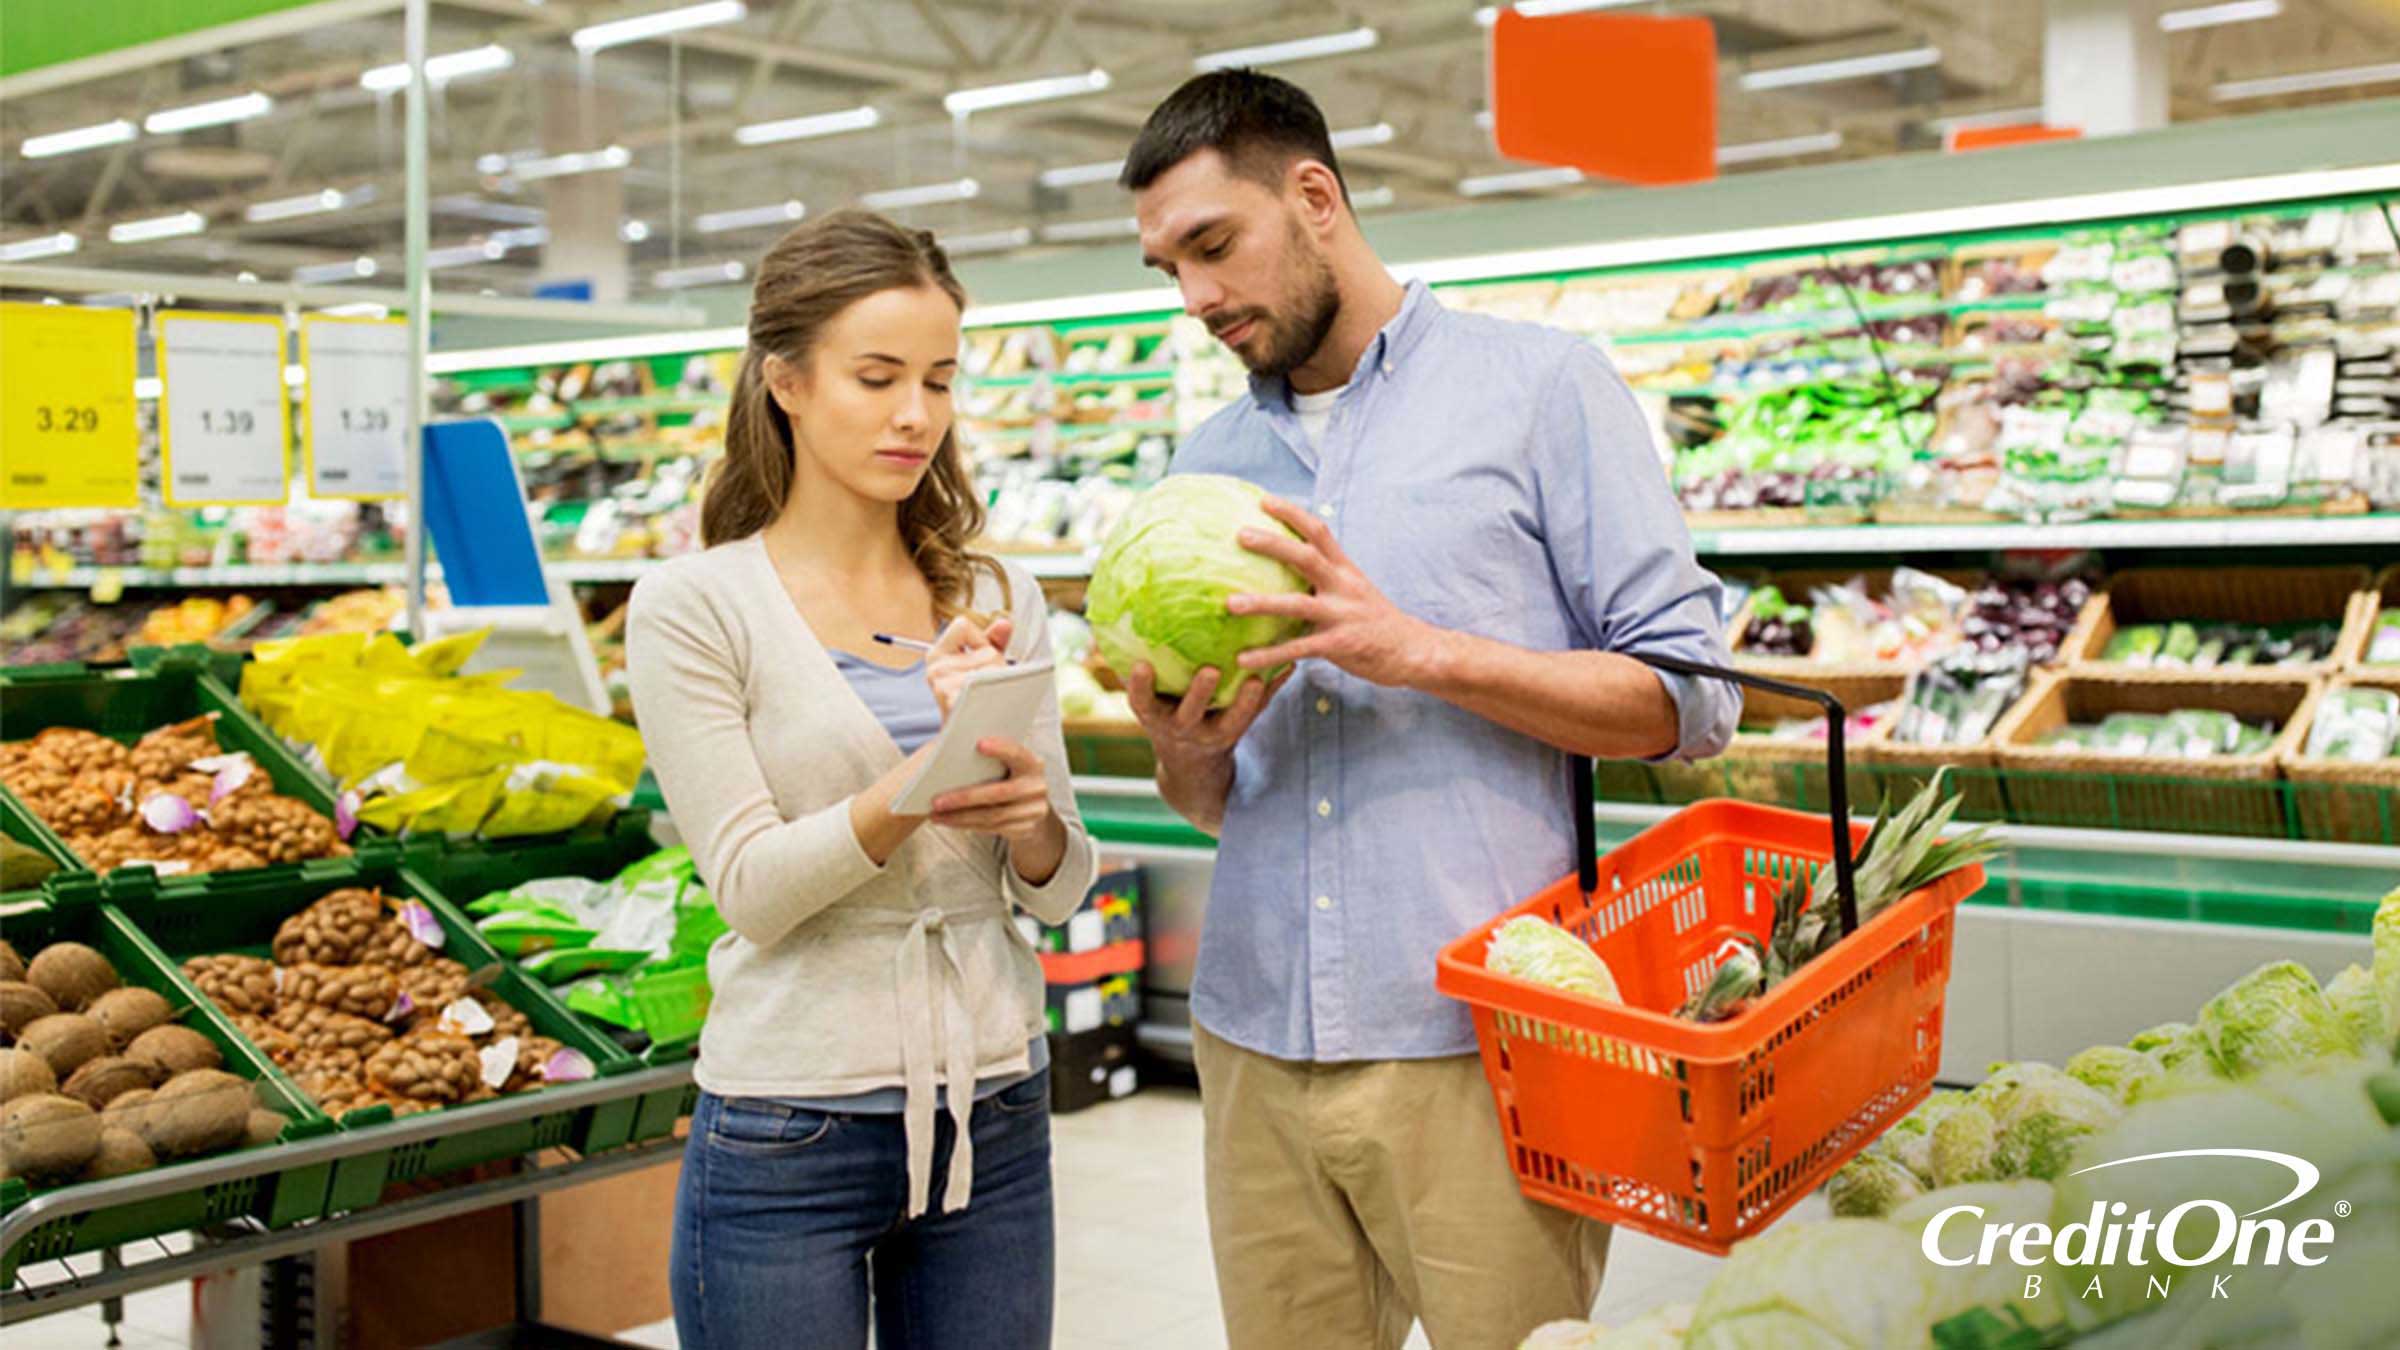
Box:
[0,305,142,512]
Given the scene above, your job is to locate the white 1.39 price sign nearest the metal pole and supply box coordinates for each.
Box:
[300,315,408,502]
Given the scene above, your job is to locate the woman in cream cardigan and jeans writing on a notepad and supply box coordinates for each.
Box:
[626,211,1094,1350]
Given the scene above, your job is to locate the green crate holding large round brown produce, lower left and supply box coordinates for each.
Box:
[0,906,334,1285]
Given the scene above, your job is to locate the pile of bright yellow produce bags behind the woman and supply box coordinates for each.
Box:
[242,632,643,838]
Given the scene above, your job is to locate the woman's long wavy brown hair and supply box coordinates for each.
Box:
[701,209,1008,622]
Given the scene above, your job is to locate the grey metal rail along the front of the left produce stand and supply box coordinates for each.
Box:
[0,1062,691,1326]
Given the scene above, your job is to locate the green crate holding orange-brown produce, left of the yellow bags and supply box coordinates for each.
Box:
[0,663,396,882]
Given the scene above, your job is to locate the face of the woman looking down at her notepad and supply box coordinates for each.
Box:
[768,286,958,504]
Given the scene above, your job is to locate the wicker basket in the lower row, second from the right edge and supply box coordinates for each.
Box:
[1992,673,2318,838]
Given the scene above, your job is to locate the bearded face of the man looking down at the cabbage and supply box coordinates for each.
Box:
[1133,149,1342,375]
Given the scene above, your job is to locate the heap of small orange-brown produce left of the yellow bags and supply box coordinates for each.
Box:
[0,713,350,874]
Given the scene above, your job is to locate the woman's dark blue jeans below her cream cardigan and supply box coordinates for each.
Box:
[670,1071,1056,1350]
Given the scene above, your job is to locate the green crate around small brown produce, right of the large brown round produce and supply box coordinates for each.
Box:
[118,862,641,1213]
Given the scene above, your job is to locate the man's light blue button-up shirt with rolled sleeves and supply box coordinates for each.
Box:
[1174,283,1740,1062]
